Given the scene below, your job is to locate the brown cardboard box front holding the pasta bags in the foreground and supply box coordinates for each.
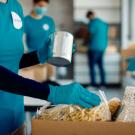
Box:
[32,119,135,135]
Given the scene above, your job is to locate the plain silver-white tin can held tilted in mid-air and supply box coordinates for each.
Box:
[48,31,74,67]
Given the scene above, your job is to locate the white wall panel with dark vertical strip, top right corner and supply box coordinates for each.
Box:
[122,0,135,49]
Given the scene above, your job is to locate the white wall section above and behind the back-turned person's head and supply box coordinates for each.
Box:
[74,0,120,23]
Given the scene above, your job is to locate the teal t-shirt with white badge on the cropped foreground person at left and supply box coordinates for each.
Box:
[0,0,24,134]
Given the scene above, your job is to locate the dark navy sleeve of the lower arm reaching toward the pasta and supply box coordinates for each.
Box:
[0,66,50,100]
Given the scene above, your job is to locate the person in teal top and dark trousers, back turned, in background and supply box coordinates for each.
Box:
[87,11,108,86]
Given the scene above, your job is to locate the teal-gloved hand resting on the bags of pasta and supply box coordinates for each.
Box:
[48,83,101,108]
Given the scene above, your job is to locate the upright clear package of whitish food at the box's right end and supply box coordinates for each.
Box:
[117,87,135,122]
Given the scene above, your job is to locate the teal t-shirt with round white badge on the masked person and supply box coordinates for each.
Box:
[24,16,55,52]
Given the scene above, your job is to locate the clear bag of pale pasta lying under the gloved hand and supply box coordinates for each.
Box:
[38,104,111,122]
